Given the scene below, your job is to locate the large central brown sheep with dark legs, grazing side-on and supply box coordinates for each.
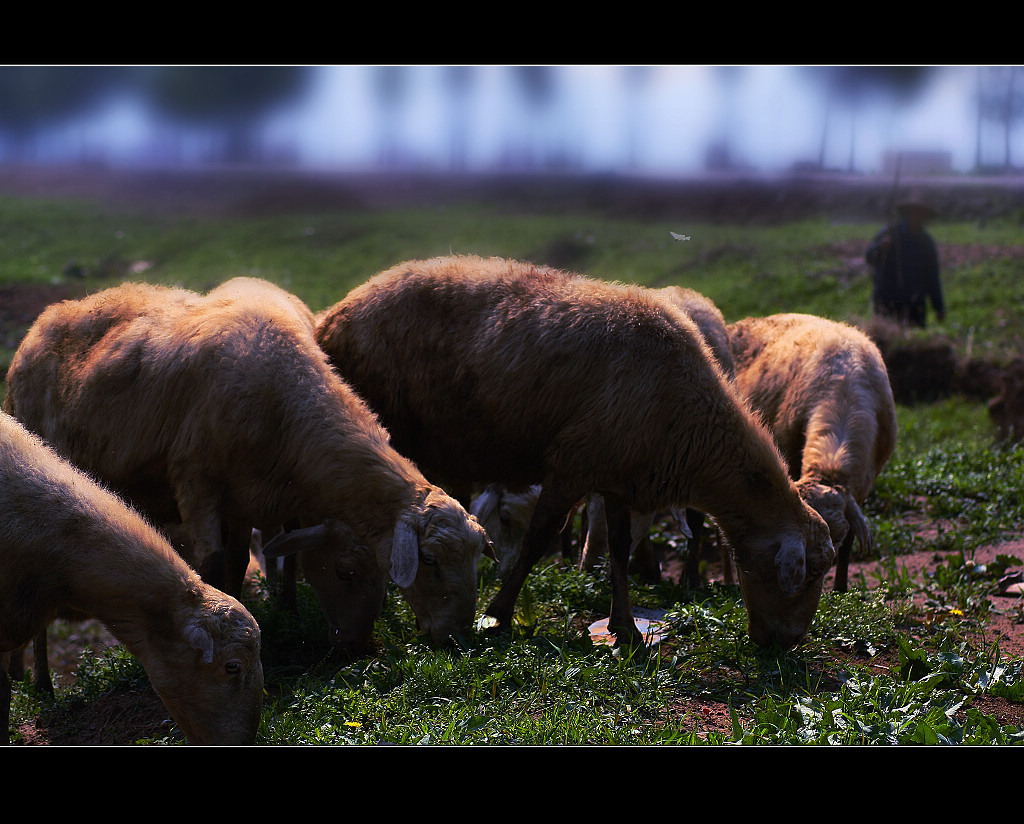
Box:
[316,256,835,648]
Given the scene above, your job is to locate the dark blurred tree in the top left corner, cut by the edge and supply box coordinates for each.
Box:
[0,66,130,162]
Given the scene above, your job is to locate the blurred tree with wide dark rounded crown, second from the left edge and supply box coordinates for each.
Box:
[137,66,311,163]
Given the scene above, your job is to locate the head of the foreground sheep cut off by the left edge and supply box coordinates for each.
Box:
[144,583,263,745]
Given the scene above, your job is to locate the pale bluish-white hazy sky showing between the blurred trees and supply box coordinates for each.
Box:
[39,66,1024,173]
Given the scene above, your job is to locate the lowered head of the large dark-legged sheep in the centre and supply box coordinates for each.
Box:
[730,505,836,649]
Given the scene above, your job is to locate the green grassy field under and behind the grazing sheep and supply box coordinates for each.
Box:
[0,181,1024,745]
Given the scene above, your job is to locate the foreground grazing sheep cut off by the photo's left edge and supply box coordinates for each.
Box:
[0,413,263,744]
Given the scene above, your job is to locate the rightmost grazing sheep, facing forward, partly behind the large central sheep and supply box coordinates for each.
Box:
[729,313,897,592]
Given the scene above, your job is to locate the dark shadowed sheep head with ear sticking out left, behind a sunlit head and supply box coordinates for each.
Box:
[263,520,387,656]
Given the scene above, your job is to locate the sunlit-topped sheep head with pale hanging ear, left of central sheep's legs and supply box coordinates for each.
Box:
[391,486,493,646]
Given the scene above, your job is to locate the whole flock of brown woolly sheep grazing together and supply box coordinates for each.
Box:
[0,256,896,743]
